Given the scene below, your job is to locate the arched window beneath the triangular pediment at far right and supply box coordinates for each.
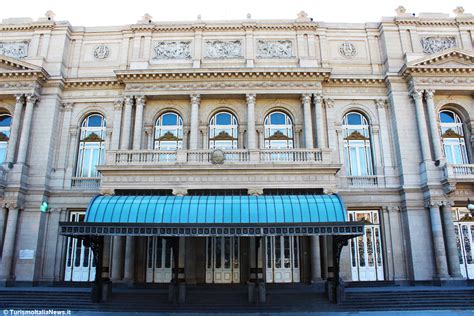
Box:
[439,110,469,164]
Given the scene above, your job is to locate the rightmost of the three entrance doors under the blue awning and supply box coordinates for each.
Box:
[265,236,300,283]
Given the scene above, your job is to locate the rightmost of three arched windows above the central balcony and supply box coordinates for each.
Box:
[264,111,294,149]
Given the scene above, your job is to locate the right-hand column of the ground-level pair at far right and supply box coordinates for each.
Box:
[441,201,462,278]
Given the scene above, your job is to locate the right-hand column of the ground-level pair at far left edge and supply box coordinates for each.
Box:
[0,205,20,281]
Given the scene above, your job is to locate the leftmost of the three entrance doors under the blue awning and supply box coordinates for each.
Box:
[146,237,173,283]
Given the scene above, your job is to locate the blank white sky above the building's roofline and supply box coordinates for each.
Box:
[0,0,474,26]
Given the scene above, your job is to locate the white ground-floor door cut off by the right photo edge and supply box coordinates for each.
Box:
[453,208,474,279]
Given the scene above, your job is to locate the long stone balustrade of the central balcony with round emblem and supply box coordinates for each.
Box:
[106,149,331,166]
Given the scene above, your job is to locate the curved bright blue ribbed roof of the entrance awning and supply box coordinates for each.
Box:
[85,195,346,224]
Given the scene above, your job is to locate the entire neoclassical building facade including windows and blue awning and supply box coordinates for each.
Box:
[0,7,474,294]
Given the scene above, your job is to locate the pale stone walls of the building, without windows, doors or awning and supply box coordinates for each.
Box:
[0,8,474,282]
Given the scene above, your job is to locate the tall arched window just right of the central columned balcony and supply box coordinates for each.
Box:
[342,112,374,176]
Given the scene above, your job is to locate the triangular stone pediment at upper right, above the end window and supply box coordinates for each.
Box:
[406,48,474,69]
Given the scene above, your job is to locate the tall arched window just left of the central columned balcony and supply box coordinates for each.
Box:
[76,114,106,178]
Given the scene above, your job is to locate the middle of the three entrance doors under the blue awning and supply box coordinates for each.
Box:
[206,237,240,283]
